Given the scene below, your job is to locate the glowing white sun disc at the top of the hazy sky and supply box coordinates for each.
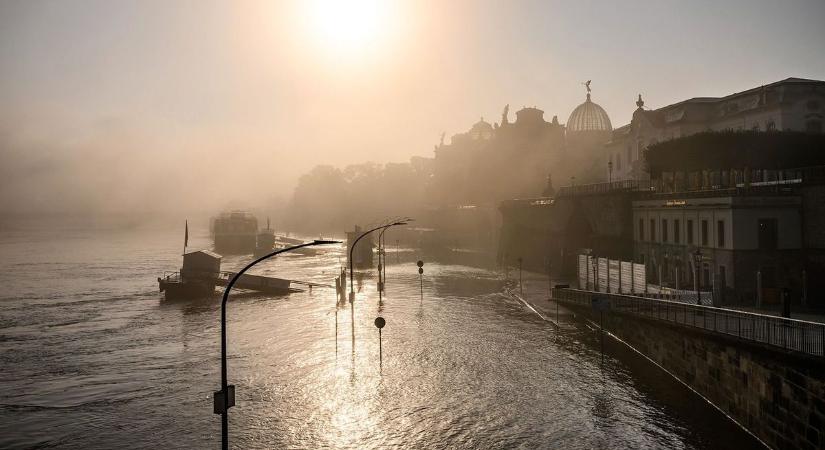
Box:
[305,0,394,56]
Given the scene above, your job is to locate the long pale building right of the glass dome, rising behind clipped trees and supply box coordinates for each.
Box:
[604,78,825,180]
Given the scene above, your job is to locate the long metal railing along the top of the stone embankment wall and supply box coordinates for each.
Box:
[552,288,825,356]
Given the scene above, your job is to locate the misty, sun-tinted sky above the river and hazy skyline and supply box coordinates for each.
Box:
[0,0,825,213]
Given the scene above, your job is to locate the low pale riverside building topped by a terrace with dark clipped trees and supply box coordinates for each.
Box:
[632,131,825,304]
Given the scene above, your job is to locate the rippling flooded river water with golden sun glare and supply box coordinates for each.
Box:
[0,227,756,449]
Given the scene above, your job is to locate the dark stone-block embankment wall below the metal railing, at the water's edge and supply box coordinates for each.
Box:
[562,303,825,449]
